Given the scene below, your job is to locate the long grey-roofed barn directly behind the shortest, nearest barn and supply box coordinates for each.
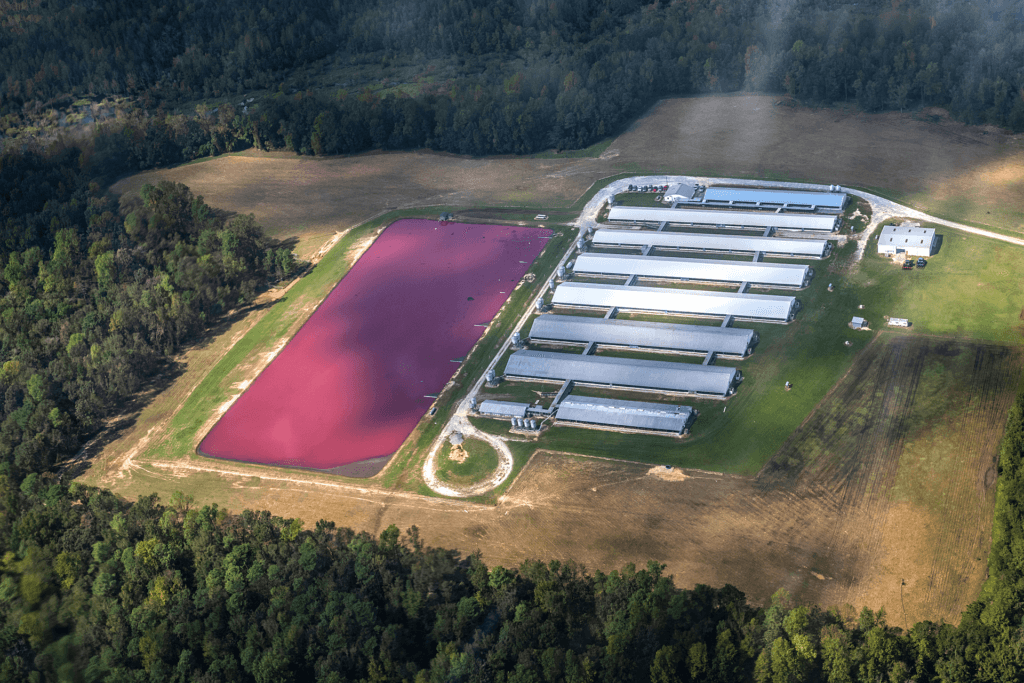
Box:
[505,350,742,398]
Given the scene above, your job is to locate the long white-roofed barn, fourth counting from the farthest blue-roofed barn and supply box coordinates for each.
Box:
[572,253,814,289]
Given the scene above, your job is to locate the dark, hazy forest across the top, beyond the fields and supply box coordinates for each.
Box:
[0,0,1024,162]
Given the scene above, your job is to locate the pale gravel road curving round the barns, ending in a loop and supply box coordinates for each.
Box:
[423,175,1024,498]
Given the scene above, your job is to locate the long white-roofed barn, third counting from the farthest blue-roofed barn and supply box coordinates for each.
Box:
[593,228,831,258]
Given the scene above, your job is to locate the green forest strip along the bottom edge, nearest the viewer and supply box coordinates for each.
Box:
[0,382,1024,683]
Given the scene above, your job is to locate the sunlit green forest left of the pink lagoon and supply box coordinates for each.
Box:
[0,148,295,480]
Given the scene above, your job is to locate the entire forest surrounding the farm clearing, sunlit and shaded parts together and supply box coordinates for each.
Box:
[0,0,1024,683]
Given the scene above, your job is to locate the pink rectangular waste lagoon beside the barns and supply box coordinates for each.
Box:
[199,219,551,469]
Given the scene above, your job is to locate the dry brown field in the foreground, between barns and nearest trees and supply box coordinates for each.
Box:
[81,334,1024,625]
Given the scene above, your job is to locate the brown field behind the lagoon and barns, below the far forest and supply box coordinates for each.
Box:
[113,95,1024,264]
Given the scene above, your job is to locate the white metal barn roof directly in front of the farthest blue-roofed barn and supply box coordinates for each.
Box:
[608,206,840,232]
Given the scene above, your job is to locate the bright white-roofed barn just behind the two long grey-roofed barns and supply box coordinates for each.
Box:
[552,283,800,323]
